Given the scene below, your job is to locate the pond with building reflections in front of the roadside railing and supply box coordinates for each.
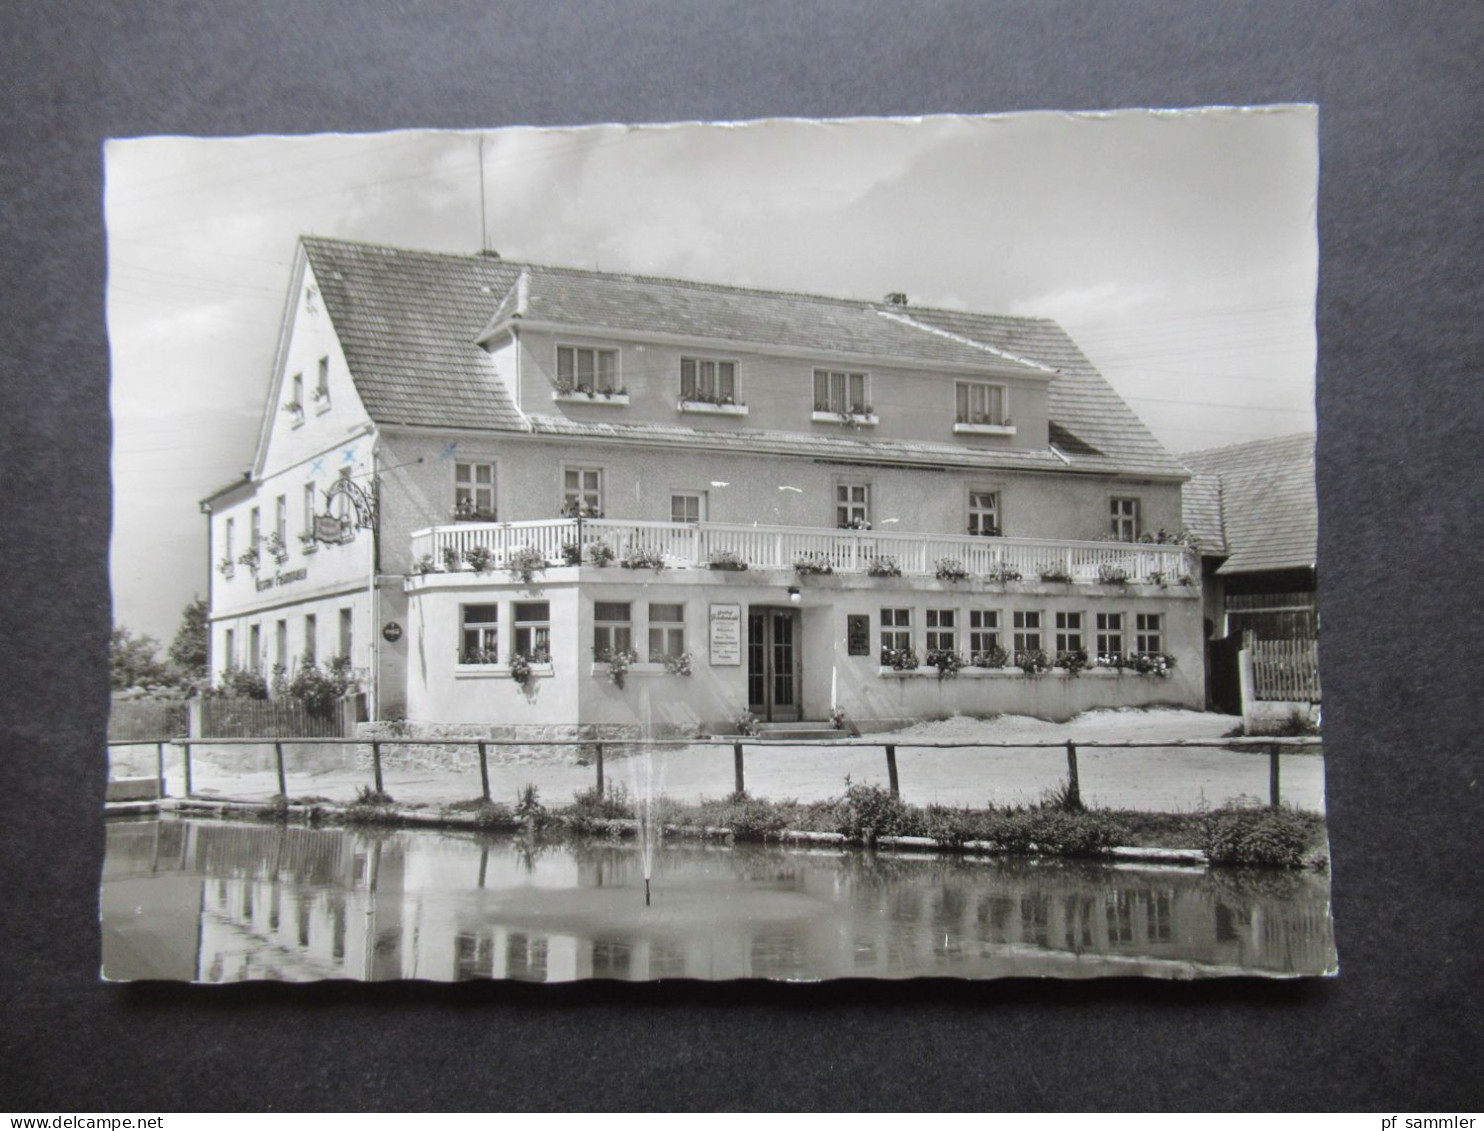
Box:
[102,818,1336,983]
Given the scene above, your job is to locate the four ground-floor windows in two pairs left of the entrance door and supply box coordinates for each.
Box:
[459,601,686,663]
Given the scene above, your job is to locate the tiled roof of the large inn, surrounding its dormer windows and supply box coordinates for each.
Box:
[303,236,1186,476]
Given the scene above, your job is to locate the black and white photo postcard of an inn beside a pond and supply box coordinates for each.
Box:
[99,104,1340,993]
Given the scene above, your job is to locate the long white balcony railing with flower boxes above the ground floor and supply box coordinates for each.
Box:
[413,518,1199,585]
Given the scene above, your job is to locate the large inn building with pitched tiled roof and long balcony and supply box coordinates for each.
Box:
[203,237,1204,733]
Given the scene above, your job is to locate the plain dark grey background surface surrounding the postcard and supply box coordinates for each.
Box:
[0,0,1484,1112]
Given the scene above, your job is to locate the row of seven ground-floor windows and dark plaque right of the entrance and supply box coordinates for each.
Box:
[866,607,1166,671]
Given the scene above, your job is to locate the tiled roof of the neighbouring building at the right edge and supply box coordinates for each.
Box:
[1181,432,1319,574]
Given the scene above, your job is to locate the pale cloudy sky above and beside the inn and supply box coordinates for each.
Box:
[104,107,1318,643]
